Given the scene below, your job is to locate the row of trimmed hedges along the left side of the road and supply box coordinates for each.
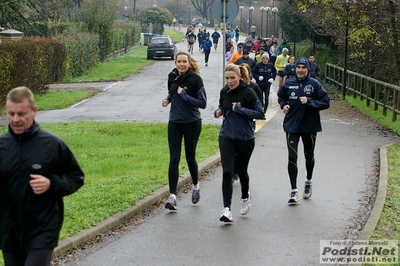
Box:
[0,21,141,102]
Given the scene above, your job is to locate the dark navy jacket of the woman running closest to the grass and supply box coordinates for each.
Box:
[167,68,207,123]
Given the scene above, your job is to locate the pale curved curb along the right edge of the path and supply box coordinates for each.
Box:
[358,144,392,240]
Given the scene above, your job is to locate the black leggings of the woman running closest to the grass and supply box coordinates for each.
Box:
[168,120,201,194]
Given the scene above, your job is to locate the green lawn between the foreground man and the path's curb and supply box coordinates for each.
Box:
[0,122,220,238]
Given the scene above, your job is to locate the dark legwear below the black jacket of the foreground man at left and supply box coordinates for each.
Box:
[3,249,53,266]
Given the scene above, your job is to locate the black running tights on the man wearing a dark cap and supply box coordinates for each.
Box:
[286,132,317,189]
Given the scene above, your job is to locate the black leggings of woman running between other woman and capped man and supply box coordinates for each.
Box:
[219,137,255,209]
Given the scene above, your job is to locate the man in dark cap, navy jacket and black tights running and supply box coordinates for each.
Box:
[278,57,330,204]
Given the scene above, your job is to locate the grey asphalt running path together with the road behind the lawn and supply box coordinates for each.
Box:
[27,28,399,266]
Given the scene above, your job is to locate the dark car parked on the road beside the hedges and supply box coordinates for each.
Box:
[147,35,176,60]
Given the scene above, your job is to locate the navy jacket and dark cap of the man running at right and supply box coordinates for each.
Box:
[278,57,330,133]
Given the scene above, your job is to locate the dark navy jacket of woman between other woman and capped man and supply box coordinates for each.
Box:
[214,81,265,141]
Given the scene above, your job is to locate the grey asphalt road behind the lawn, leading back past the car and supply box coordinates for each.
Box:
[28,33,228,123]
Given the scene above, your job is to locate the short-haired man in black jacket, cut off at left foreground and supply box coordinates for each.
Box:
[0,87,84,266]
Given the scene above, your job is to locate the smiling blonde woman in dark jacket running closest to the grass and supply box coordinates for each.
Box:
[162,51,207,210]
